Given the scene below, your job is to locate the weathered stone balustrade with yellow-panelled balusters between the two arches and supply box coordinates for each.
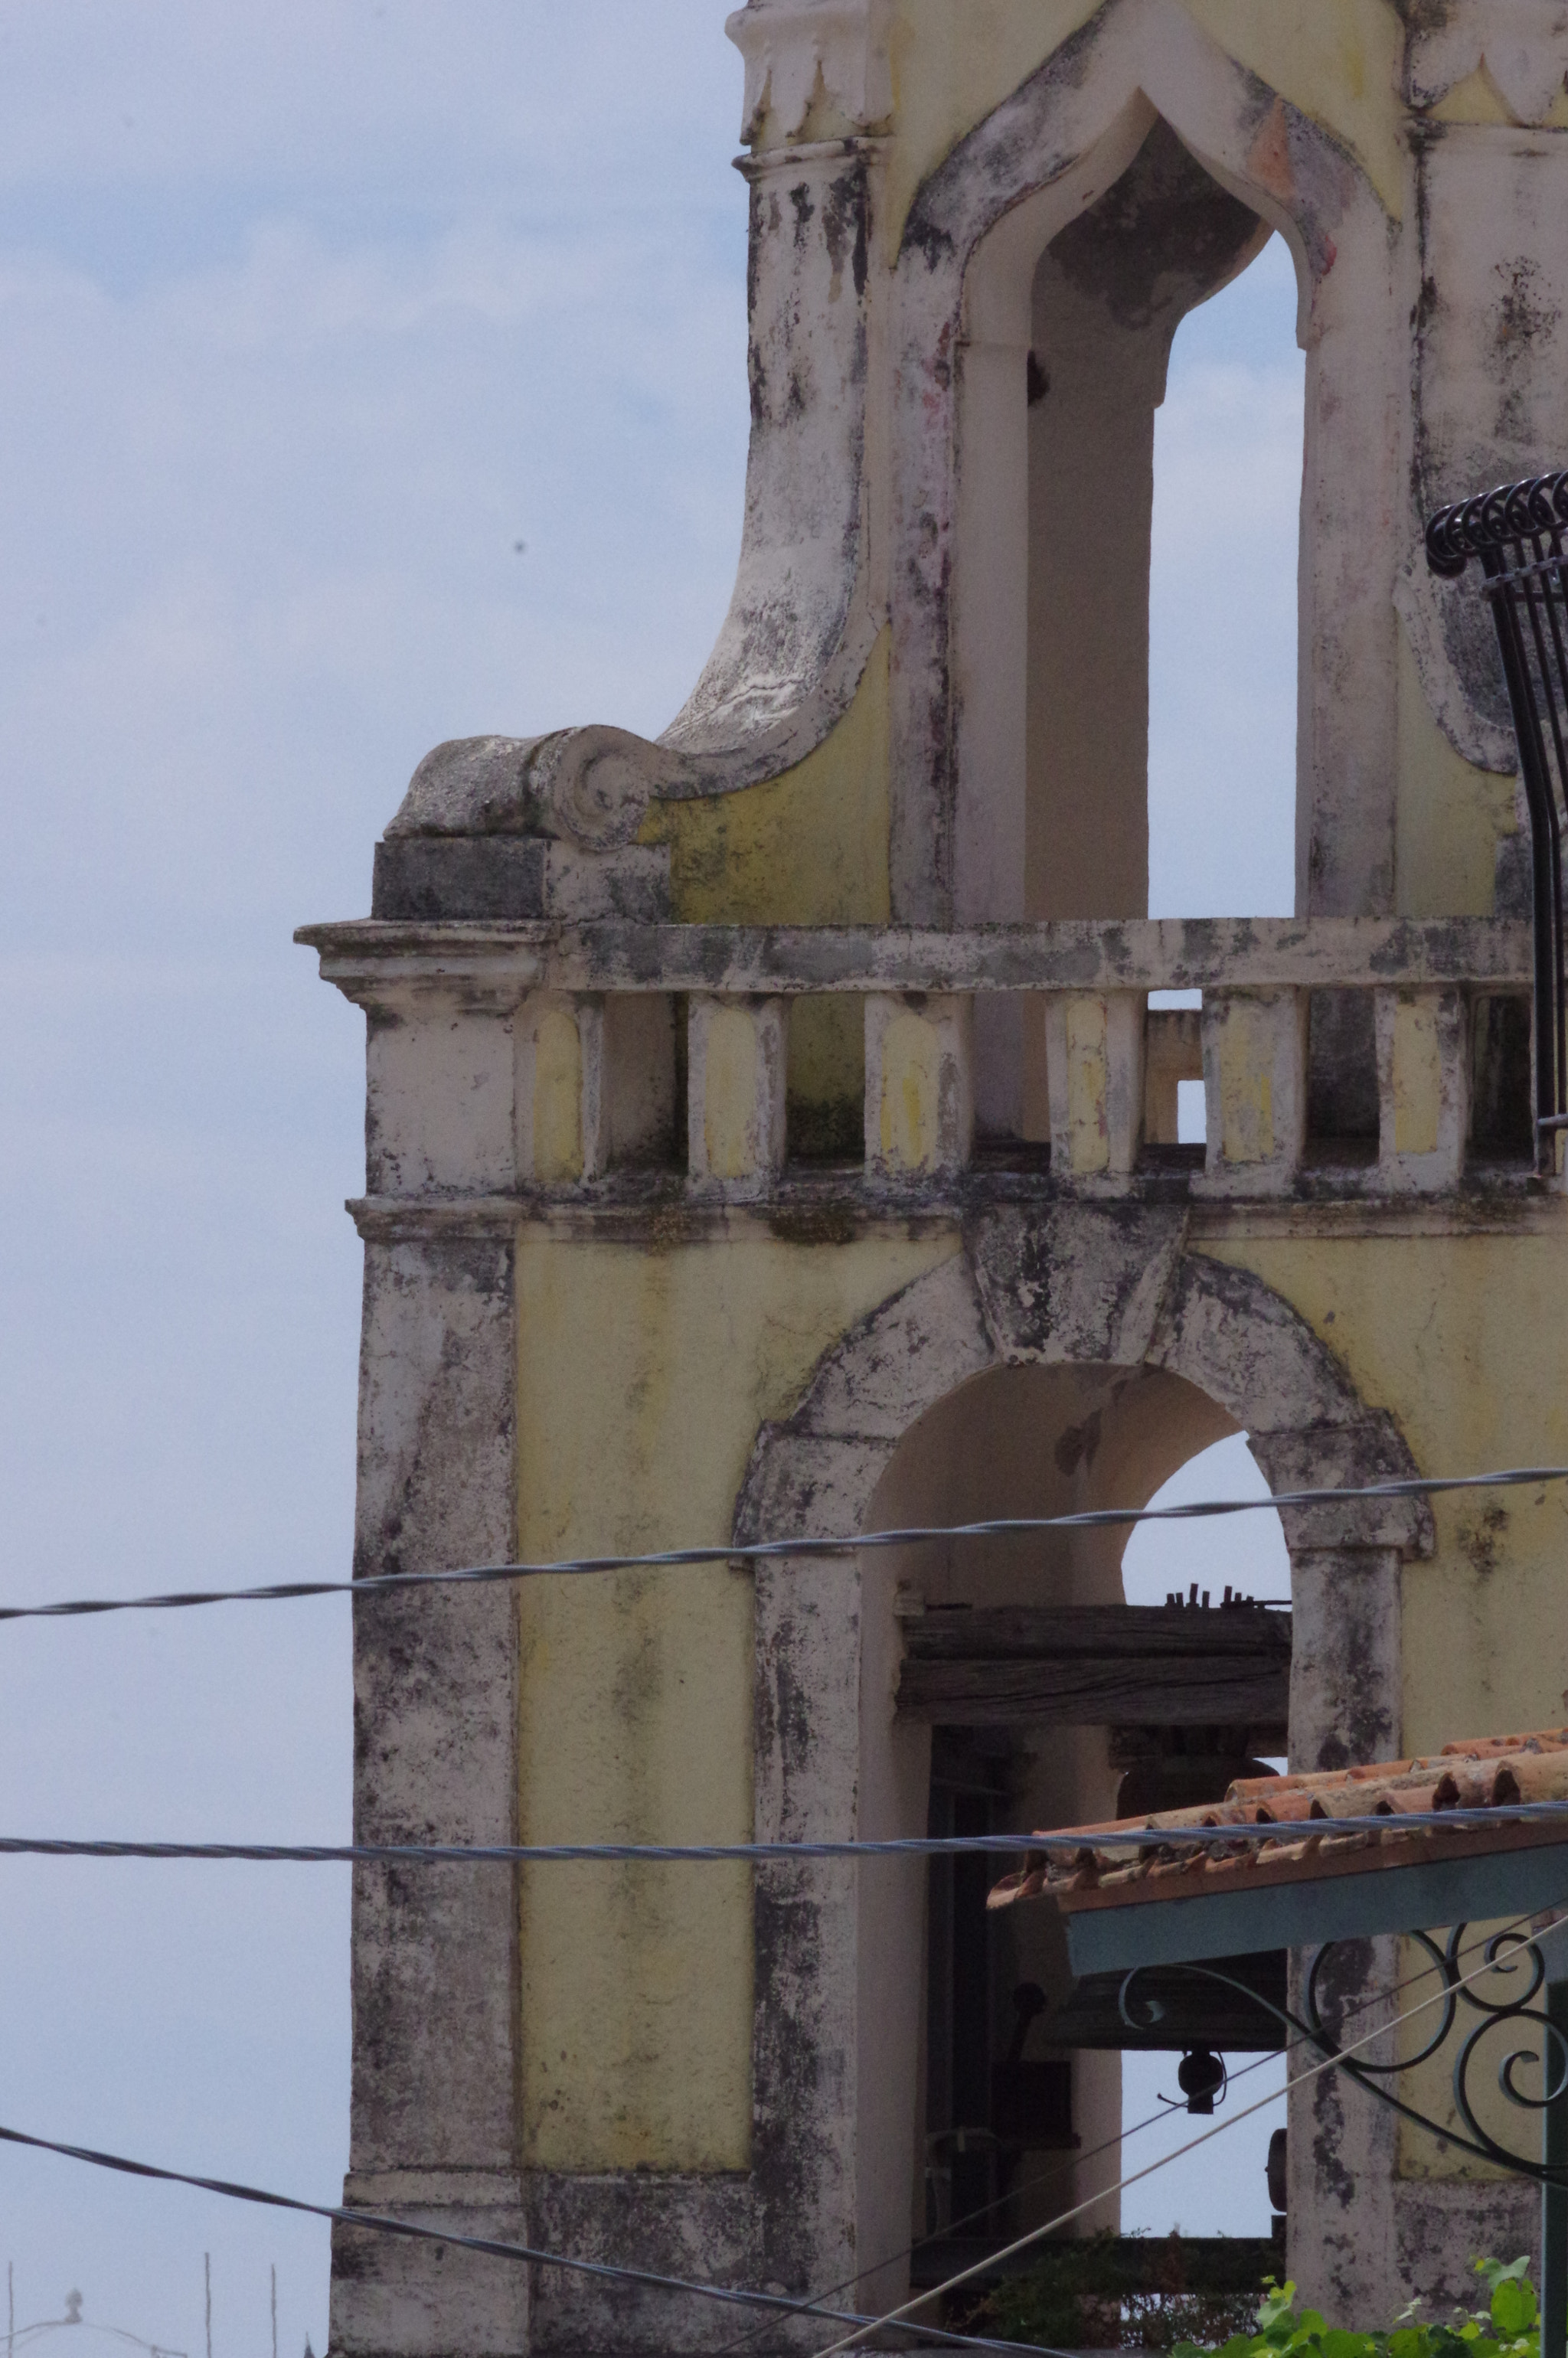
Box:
[297,919,1530,1200]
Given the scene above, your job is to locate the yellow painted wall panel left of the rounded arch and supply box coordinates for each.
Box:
[516,1217,955,2170]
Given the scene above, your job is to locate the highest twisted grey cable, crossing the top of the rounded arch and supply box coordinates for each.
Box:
[0,1467,1568,1620]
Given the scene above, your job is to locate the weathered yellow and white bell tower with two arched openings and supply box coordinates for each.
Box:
[299,0,1568,2358]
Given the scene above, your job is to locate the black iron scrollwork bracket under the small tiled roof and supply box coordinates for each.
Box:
[1118,1924,1568,2188]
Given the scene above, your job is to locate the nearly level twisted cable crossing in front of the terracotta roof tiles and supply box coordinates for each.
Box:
[0,1801,1568,1867]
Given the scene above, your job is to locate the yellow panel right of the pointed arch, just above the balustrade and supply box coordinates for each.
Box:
[1393,622,1518,917]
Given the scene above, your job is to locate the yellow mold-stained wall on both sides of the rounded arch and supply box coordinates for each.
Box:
[519,1210,1568,2172]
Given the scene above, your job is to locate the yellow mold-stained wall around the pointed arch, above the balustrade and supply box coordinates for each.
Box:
[642,0,1518,948]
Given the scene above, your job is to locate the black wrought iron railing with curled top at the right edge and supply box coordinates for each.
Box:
[1426,469,1568,1168]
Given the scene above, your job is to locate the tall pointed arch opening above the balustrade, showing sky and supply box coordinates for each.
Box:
[952,96,1302,1139]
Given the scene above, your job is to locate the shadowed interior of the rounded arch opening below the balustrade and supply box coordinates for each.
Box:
[856,1363,1282,2299]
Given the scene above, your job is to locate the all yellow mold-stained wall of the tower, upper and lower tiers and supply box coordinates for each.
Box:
[505,0,1568,2172]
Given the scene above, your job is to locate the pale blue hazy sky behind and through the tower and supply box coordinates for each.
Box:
[0,0,1302,2358]
